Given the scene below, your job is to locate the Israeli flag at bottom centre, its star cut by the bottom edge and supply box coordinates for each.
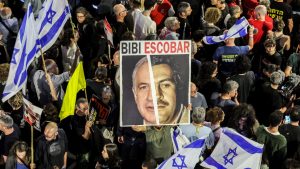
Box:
[157,137,206,169]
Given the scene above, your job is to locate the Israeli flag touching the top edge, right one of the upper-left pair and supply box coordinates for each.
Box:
[36,0,71,52]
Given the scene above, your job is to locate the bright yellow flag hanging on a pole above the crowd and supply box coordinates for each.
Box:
[59,62,86,120]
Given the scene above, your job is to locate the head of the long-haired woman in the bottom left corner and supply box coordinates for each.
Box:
[9,141,29,161]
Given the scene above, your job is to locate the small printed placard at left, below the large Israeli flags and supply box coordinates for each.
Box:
[23,98,43,131]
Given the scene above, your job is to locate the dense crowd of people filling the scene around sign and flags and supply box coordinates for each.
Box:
[0,0,300,169]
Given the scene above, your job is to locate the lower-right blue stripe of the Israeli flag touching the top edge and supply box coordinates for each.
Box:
[40,7,69,47]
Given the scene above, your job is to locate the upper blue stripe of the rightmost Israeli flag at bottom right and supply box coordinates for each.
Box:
[223,130,263,154]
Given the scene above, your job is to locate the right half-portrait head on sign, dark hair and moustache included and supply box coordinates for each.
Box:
[151,56,183,124]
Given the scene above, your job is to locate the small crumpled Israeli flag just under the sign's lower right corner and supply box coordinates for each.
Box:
[170,127,190,153]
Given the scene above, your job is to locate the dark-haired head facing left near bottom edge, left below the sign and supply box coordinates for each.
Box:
[101,143,120,167]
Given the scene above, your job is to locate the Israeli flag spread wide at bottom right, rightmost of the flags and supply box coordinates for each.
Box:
[201,128,263,169]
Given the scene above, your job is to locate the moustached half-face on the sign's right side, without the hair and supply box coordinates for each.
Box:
[152,64,176,124]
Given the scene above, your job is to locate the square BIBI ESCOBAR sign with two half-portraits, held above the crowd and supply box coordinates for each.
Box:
[120,41,191,126]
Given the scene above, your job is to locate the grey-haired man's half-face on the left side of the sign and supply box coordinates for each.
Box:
[133,62,156,124]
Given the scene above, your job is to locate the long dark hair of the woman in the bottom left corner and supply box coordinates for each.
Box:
[5,141,30,169]
